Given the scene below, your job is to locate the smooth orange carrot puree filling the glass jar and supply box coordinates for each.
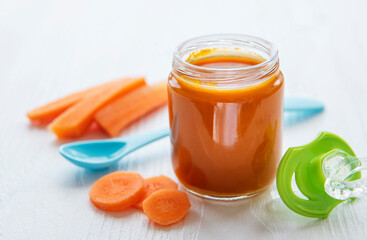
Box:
[168,56,283,197]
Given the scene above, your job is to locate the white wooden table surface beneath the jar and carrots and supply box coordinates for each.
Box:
[0,0,367,240]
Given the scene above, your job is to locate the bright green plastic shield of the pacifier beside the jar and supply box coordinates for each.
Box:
[277,132,361,218]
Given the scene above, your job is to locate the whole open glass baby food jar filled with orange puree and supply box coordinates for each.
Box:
[168,35,283,200]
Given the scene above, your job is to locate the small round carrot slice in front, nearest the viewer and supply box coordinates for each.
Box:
[143,189,191,225]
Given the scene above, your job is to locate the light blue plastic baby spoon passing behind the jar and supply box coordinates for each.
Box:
[59,98,324,170]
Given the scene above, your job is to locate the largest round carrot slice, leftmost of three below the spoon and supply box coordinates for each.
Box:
[89,172,144,212]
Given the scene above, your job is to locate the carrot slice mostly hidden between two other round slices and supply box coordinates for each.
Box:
[134,175,178,210]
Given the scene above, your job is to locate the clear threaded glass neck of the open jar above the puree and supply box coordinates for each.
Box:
[172,34,279,88]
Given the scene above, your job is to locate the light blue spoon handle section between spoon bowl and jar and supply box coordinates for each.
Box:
[122,128,171,154]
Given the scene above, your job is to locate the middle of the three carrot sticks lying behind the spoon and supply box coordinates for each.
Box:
[49,78,145,138]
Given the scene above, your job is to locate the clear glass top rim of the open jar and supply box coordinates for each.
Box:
[173,34,278,72]
